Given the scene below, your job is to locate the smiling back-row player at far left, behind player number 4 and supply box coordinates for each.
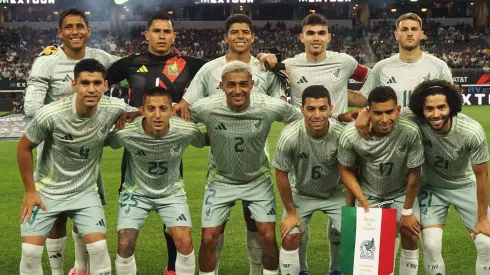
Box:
[24,8,118,275]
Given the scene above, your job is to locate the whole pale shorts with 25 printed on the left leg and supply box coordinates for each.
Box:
[117,190,192,231]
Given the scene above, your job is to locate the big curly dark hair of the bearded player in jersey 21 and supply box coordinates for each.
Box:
[408,80,463,119]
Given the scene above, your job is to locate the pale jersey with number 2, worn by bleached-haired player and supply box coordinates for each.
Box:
[191,92,301,185]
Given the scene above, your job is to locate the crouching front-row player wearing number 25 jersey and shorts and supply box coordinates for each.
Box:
[107,87,205,275]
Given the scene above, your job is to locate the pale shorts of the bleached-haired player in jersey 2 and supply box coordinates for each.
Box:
[201,178,276,227]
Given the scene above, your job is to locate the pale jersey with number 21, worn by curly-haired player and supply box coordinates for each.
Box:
[402,111,489,189]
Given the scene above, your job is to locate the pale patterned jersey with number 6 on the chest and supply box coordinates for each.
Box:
[272,119,343,199]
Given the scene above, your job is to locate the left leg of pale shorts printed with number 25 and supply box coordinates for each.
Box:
[116,190,154,231]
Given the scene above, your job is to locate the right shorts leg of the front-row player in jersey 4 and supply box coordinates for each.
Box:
[67,191,107,236]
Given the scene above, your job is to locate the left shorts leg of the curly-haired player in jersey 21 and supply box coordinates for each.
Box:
[418,186,450,227]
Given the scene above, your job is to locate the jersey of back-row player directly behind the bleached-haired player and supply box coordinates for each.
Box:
[184,56,285,105]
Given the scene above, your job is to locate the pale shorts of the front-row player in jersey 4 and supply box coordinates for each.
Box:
[20,190,106,237]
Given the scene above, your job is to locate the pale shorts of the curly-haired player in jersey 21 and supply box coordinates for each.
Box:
[419,184,490,229]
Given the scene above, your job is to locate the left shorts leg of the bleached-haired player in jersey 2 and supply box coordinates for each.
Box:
[201,183,236,227]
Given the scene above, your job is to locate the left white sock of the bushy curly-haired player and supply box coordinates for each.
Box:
[422,228,446,275]
